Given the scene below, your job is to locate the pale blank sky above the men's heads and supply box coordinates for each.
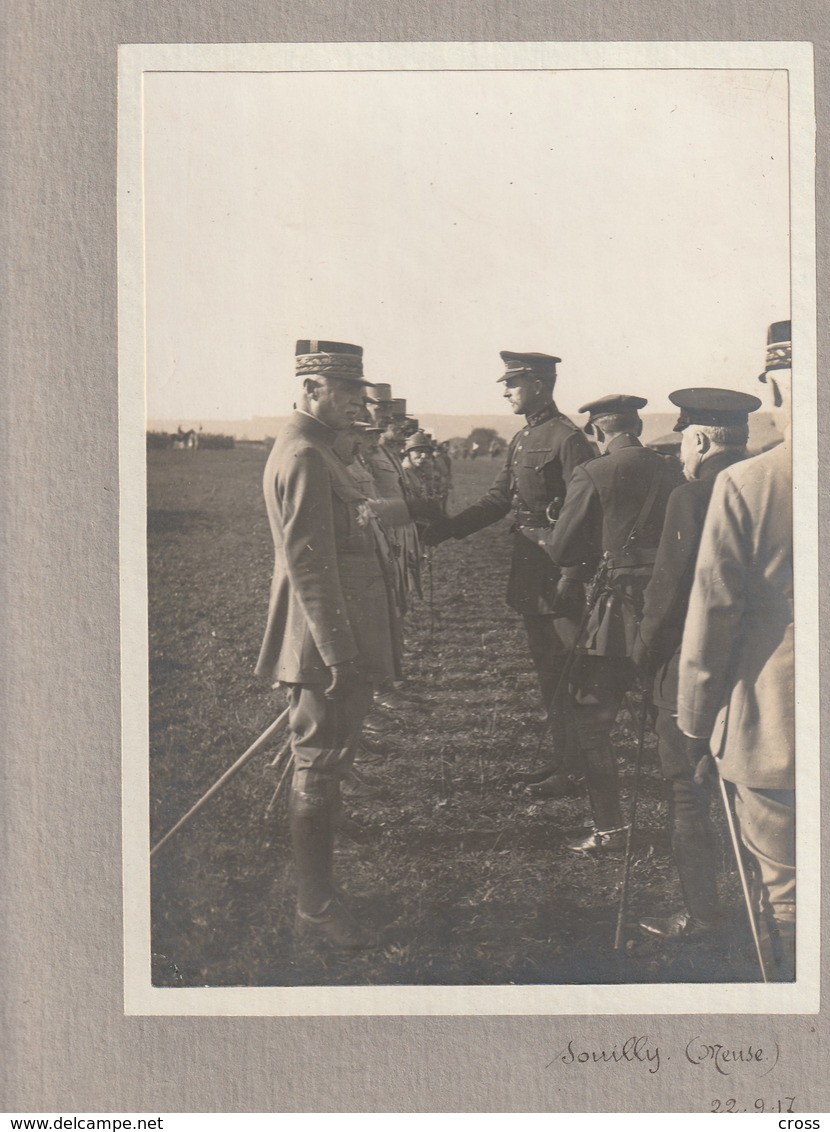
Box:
[144,70,790,420]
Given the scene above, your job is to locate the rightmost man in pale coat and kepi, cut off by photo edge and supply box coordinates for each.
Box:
[677,321,796,980]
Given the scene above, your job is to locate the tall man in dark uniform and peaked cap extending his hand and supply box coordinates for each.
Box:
[423,350,593,797]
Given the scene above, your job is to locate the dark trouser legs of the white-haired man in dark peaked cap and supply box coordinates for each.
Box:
[657,708,718,924]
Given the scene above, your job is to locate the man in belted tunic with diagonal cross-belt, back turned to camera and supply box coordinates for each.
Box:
[544,394,681,854]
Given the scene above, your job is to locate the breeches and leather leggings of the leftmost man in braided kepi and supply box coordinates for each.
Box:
[289,685,371,912]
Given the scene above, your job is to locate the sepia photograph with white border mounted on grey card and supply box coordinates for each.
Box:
[119,43,820,1014]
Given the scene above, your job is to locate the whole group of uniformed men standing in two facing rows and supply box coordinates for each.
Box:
[253,324,795,977]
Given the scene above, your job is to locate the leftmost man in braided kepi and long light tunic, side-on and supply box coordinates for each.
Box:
[257,341,394,949]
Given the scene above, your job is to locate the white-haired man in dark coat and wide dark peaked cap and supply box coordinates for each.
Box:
[634,388,761,940]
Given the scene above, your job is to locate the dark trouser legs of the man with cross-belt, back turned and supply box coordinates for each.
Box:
[573,657,633,830]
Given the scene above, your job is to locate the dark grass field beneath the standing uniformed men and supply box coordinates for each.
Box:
[148,447,758,986]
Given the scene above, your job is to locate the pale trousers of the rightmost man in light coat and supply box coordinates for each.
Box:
[735,783,796,979]
